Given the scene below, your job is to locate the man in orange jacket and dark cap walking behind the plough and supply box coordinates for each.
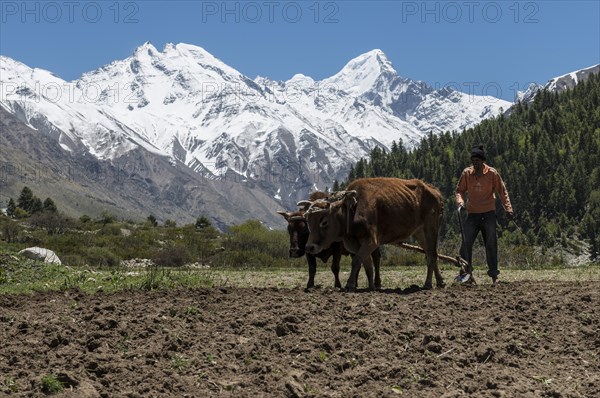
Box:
[456,144,513,285]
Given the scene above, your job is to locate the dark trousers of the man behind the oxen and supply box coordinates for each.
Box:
[460,211,500,278]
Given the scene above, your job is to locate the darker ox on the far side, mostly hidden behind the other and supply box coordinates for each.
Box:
[277,192,381,290]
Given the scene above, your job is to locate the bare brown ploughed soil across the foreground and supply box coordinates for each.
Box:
[0,282,600,398]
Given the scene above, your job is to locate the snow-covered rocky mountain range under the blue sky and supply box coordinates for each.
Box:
[0,43,511,224]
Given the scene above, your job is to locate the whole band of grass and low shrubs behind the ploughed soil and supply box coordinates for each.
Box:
[0,217,600,294]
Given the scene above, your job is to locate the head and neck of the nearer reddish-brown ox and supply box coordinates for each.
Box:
[298,191,356,254]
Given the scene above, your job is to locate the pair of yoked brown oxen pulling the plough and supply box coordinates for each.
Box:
[278,178,461,291]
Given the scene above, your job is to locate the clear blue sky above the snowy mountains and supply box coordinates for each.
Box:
[0,0,600,100]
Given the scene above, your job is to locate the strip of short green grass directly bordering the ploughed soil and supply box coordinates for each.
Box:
[0,254,600,294]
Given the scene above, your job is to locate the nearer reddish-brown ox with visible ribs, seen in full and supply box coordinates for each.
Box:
[305,178,444,290]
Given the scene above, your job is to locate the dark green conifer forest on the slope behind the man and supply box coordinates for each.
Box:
[336,75,600,261]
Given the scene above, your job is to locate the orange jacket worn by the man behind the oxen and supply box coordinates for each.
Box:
[456,163,512,213]
